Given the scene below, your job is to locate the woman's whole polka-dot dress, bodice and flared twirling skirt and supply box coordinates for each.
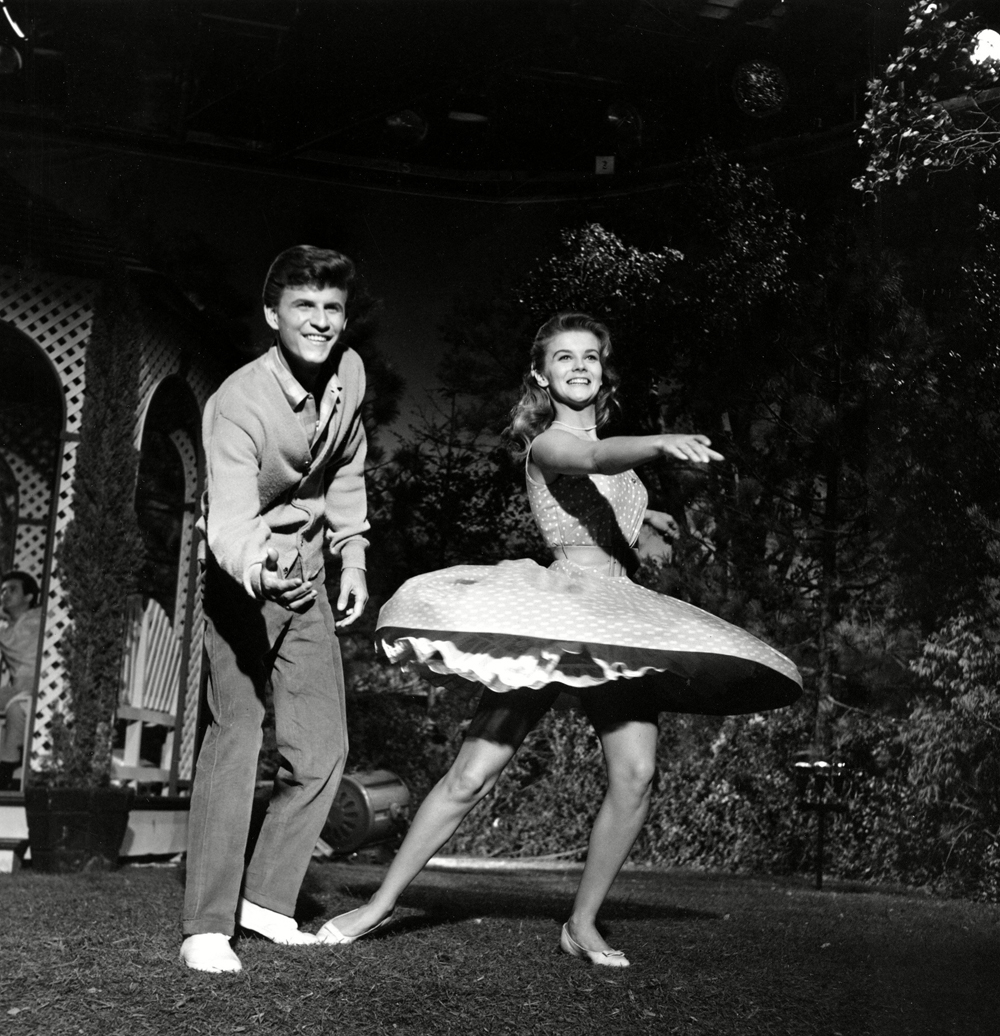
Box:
[375,459,801,715]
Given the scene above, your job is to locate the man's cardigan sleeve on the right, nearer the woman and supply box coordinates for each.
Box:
[325,357,370,569]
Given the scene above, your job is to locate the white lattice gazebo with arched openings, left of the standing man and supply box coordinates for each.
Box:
[0,174,231,869]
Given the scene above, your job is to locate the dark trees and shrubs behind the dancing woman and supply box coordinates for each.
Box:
[341,127,1000,898]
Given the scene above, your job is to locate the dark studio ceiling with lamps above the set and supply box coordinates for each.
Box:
[0,0,990,201]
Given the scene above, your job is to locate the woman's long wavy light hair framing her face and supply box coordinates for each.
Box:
[504,313,619,460]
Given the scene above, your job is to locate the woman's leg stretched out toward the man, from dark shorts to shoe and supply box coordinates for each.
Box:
[330,691,556,937]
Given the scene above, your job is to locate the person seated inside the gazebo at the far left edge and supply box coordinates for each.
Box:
[0,571,41,792]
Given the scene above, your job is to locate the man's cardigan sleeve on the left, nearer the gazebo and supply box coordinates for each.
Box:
[204,405,270,598]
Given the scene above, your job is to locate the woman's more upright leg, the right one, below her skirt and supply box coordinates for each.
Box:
[568,703,657,950]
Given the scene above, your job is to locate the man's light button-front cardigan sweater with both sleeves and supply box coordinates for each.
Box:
[199,344,369,597]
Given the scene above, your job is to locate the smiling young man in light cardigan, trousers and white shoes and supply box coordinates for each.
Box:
[180,246,368,972]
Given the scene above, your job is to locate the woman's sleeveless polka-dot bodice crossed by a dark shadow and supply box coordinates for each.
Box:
[526,471,649,556]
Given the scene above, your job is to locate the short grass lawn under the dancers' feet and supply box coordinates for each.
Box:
[0,863,1000,1036]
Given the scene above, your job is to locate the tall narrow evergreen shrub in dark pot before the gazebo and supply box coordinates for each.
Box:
[25,271,143,871]
